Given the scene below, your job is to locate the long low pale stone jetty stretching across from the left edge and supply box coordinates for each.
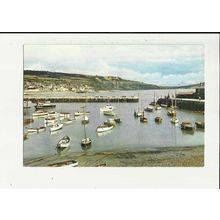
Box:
[24,95,139,103]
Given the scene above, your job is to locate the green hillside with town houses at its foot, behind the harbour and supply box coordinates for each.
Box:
[24,70,164,91]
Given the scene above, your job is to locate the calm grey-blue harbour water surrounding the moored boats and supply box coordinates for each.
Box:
[24,90,204,159]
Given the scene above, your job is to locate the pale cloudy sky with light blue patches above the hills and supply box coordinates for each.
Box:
[24,44,204,86]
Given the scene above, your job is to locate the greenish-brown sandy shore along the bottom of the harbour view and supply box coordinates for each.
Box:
[24,146,204,167]
